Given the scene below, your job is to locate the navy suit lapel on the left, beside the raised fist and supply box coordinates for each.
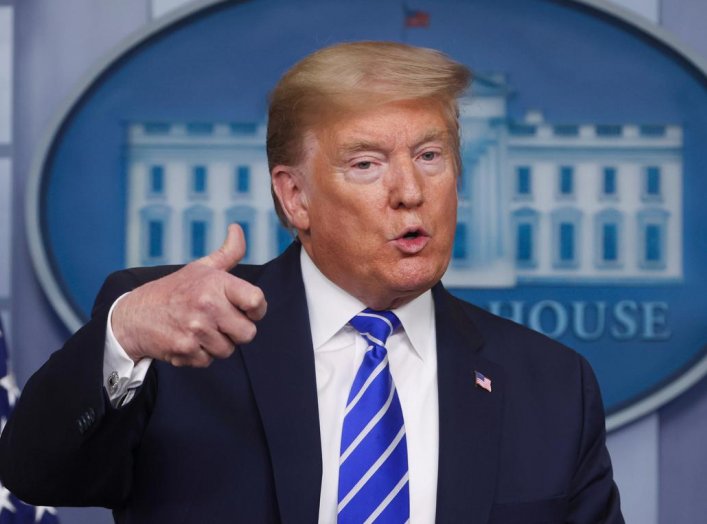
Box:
[241,247,322,523]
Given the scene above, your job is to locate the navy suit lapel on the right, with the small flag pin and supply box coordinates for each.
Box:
[433,285,504,523]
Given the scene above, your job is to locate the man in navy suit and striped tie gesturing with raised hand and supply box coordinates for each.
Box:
[0,43,623,524]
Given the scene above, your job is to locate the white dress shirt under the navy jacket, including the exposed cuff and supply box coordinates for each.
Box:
[103,249,439,524]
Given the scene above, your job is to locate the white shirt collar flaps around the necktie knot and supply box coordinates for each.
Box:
[300,248,435,360]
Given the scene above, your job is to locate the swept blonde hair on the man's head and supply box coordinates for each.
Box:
[267,42,471,227]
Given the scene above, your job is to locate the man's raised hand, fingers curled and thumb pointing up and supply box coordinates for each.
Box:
[111,224,267,367]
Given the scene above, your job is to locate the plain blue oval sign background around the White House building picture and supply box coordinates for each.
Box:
[38,0,707,420]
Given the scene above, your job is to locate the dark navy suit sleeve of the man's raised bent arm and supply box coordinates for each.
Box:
[0,271,157,507]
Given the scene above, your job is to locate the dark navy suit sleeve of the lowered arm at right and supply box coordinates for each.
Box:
[567,357,624,524]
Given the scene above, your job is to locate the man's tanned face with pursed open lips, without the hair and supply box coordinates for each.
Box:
[295,101,457,309]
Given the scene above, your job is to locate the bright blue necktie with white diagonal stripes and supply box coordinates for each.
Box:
[337,309,410,524]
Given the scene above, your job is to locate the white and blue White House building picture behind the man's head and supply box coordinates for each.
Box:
[125,75,683,287]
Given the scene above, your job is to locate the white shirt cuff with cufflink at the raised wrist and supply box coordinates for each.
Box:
[103,293,152,407]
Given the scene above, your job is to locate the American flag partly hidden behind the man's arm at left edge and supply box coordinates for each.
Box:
[0,318,59,524]
